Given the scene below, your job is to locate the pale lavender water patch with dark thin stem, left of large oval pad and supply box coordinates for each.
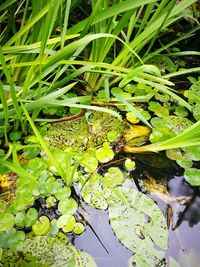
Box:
[74,205,133,267]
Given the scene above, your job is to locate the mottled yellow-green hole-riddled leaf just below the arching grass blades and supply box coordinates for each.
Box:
[44,111,124,150]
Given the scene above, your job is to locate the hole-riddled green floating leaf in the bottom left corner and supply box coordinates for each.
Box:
[0,236,76,267]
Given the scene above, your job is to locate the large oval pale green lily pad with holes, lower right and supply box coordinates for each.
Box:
[108,187,168,266]
